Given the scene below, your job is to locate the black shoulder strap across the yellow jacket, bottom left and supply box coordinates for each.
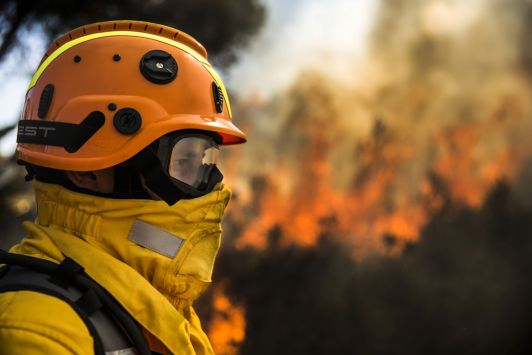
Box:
[0,250,151,355]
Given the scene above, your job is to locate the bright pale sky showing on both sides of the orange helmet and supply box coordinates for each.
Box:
[0,0,378,156]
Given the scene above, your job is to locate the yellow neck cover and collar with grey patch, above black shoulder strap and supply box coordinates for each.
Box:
[12,181,231,354]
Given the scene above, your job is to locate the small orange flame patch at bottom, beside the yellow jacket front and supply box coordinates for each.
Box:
[209,287,246,355]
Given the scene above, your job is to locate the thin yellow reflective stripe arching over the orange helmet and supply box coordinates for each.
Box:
[28,31,208,89]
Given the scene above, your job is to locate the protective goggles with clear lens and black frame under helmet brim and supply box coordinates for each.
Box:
[114,130,223,205]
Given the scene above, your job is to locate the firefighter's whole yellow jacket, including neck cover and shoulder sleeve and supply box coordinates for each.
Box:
[0,181,230,355]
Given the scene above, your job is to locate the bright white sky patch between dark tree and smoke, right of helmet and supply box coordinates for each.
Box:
[226,0,378,97]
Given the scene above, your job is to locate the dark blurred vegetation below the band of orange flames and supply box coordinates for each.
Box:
[207,182,532,355]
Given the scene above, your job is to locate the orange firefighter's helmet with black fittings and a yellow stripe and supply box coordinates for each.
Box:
[17,21,246,171]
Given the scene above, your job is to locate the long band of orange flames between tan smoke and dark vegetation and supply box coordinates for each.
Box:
[233,84,532,256]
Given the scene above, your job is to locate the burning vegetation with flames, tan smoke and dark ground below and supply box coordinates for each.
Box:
[201,0,532,354]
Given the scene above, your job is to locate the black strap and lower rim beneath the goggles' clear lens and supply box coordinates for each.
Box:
[130,147,223,206]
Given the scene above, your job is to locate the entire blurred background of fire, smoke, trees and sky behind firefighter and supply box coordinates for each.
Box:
[0,0,532,354]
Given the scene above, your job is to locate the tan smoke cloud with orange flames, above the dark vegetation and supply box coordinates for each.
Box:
[221,0,532,255]
